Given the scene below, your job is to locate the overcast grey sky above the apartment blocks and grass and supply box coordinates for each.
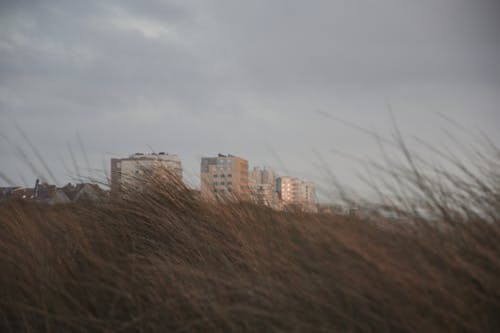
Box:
[0,0,500,197]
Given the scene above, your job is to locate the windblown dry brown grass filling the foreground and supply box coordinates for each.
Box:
[0,142,500,332]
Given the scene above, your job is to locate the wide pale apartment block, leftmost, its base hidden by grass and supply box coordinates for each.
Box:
[111,152,182,192]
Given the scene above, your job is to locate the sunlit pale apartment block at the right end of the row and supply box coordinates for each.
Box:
[276,177,316,211]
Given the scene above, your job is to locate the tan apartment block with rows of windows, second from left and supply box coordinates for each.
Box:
[200,154,250,200]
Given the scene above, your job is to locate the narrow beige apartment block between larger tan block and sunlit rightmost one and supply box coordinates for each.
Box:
[250,167,279,208]
